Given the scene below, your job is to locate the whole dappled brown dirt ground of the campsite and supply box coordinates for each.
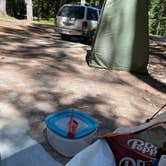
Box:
[0,20,166,163]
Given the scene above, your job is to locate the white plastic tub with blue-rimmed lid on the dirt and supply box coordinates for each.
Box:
[45,110,98,157]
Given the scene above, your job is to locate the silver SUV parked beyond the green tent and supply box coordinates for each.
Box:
[56,4,100,42]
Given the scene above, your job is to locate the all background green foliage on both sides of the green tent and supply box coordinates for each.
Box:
[6,0,166,36]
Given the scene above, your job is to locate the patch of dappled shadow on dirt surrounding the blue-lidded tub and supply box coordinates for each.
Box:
[0,88,118,163]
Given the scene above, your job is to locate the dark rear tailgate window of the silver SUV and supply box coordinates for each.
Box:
[58,6,85,19]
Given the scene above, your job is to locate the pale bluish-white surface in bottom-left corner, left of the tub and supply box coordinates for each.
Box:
[0,124,62,166]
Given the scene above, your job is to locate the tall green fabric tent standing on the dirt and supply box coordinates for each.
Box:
[87,0,148,73]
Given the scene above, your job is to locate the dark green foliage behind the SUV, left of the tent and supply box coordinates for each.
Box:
[6,0,103,20]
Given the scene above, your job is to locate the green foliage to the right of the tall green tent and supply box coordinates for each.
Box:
[149,0,166,36]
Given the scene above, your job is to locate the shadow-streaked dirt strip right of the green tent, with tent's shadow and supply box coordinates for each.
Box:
[135,37,166,93]
